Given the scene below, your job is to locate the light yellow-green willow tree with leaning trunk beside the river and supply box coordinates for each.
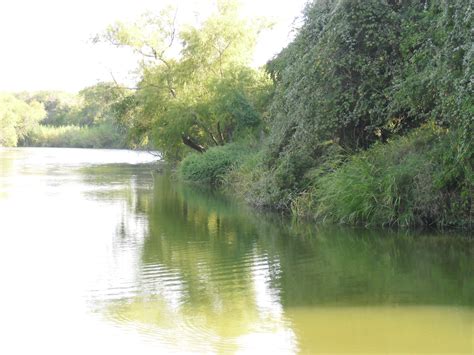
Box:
[105,1,269,159]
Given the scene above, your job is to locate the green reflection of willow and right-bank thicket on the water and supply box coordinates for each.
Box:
[143,178,473,306]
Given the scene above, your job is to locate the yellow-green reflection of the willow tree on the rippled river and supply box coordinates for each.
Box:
[142,177,274,336]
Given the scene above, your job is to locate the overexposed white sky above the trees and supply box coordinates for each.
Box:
[0,0,307,92]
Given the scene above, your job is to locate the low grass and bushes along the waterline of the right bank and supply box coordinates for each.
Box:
[178,127,473,229]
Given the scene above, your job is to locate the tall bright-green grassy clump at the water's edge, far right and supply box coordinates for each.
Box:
[292,128,473,227]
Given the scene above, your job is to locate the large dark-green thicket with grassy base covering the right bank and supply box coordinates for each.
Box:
[223,0,474,226]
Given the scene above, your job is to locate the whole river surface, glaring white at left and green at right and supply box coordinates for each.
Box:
[0,149,474,354]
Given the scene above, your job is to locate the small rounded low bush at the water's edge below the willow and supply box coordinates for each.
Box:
[179,143,249,185]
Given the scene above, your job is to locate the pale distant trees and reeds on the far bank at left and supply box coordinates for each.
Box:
[0,83,129,148]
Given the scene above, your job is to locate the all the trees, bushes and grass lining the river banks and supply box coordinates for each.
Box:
[0,0,474,227]
